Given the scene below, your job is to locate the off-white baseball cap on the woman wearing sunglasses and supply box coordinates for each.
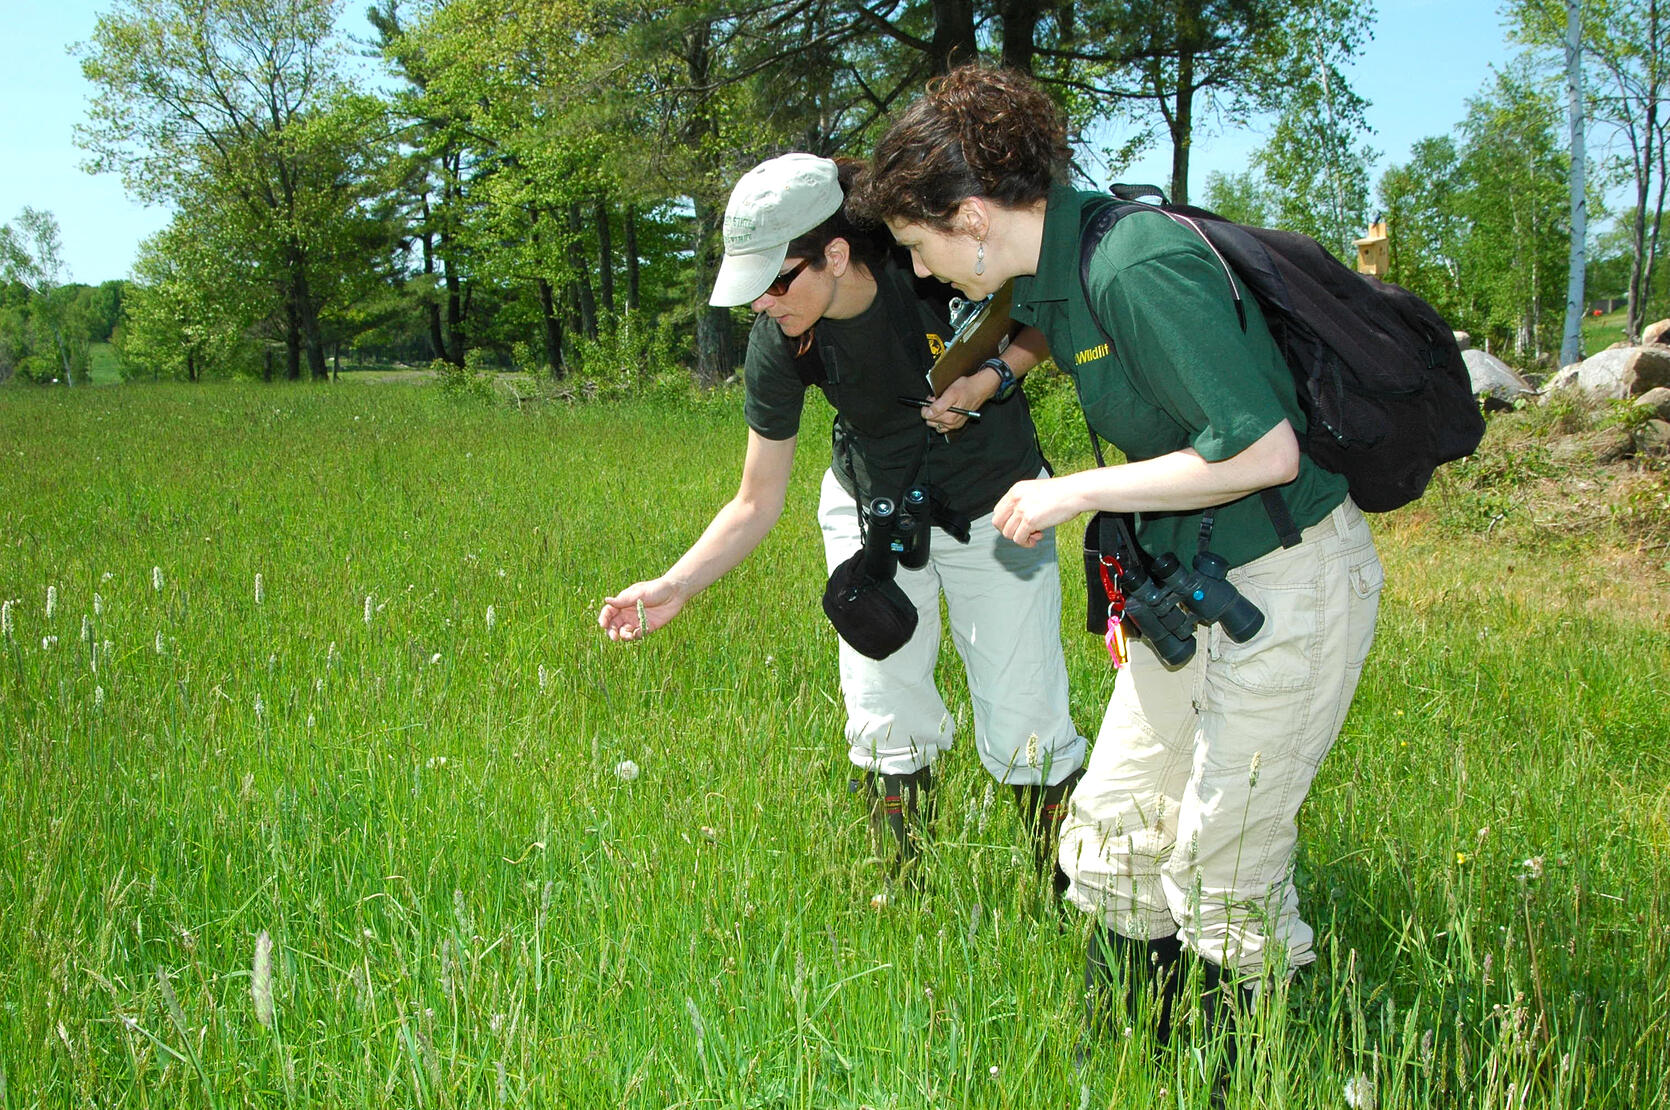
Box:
[708,154,845,307]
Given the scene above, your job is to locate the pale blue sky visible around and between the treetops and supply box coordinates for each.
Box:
[0,0,1513,284]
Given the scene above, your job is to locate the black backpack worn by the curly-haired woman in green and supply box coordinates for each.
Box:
[1079,185,1485,520]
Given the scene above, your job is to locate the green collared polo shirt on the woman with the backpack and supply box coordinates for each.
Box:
[1014,185,1346,566]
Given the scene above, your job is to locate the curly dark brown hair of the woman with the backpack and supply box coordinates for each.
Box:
[847,62,1069,230]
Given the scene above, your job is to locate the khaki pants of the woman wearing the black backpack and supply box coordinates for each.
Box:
[1060,499,1384,970]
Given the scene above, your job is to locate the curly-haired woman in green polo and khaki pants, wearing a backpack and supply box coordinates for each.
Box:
[855,65,1383,1068]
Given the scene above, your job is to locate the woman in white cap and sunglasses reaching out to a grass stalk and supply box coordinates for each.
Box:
[598,154,1086,868]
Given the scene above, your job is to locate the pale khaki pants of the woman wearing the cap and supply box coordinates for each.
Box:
[818,471,1086,786]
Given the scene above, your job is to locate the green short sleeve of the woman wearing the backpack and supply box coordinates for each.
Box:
[1097,229,1298,462]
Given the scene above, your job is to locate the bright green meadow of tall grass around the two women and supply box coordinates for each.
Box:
[0,378,1670,1110]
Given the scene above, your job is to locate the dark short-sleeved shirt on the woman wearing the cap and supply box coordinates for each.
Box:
[743,264,1044,517]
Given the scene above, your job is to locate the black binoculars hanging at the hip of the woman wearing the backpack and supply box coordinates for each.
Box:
[1124,551,1264,666]
